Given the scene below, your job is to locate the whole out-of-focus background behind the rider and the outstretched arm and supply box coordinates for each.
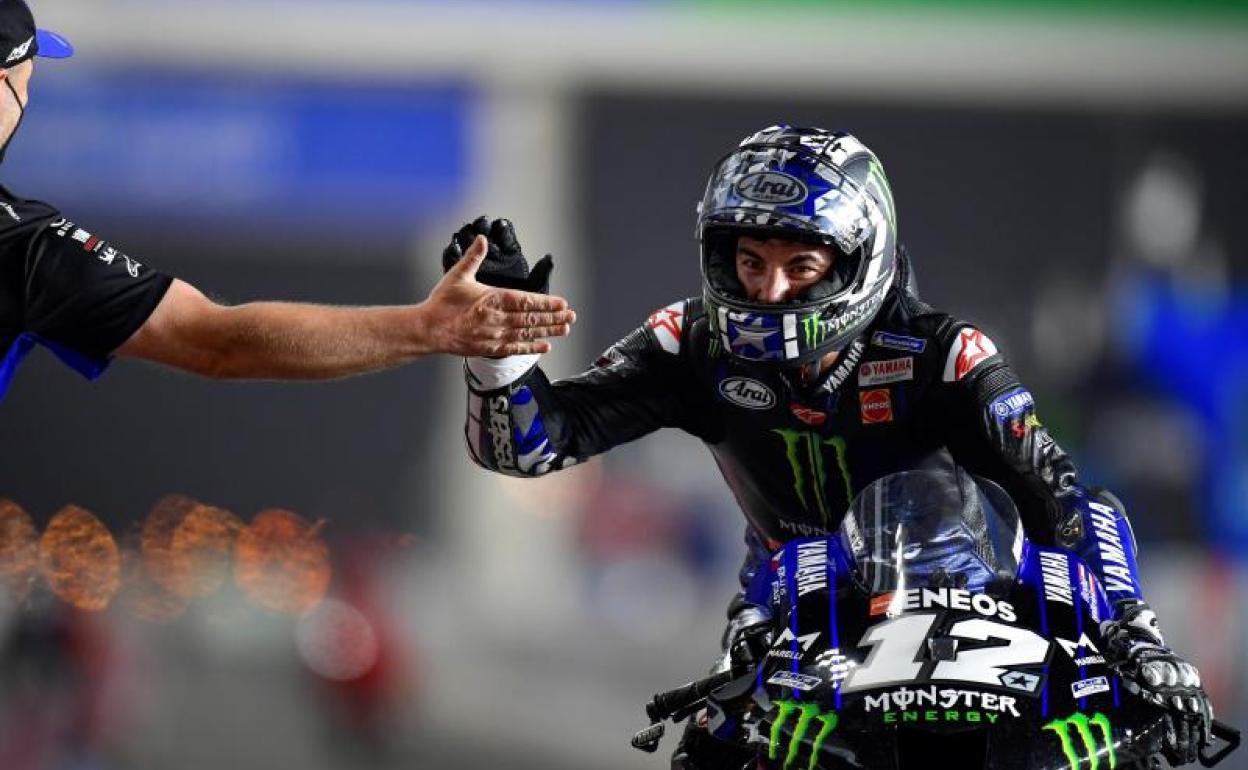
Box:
[0,0,1248,770]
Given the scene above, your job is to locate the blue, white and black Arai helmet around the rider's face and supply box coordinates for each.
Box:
[696,126,897,367]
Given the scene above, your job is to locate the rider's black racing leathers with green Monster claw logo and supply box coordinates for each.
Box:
[466,279,1139,621]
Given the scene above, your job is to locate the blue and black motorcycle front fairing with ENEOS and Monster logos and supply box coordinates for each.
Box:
[738,469,1164,770]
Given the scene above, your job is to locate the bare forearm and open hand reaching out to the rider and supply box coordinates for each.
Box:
[116,237,575,379]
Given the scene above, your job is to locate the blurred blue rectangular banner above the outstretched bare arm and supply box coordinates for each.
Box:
[0,68,475,230]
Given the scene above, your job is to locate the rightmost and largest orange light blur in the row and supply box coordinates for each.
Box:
[235,508,332,614]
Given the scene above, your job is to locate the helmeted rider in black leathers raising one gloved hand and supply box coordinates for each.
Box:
[443,126,1212,768]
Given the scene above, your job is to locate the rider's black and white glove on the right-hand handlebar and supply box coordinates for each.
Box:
[1101,600,1213,768]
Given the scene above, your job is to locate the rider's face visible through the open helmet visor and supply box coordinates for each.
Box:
[736,236,834,303]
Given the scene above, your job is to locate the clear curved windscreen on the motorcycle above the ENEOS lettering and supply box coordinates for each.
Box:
[841,468,1023,595]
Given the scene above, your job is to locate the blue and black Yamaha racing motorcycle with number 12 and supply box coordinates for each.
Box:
[633,469,1239,770]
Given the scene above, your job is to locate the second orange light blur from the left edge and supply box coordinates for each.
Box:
[39,505,121,612]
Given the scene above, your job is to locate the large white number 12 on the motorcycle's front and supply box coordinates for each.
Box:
[841,613,1050,693]
